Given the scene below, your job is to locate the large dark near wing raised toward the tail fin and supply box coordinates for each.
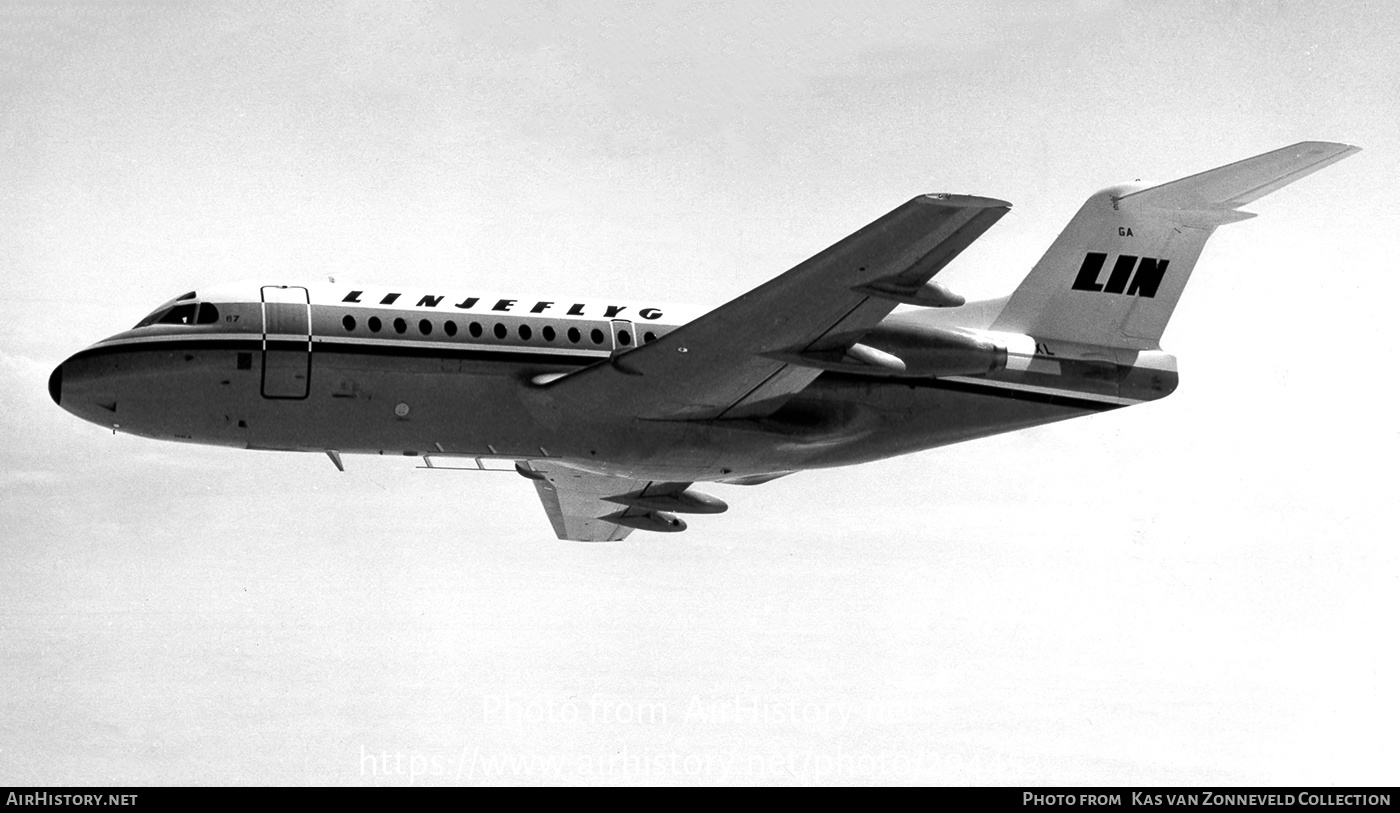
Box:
[532,195,1011,420]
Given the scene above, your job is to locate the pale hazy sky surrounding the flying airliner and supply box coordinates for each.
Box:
[0,0,1400,785]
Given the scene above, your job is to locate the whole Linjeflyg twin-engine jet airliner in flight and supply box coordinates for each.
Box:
[49,141,1358,542]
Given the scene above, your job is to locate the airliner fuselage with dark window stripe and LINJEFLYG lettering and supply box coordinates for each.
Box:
[50,278,1175,481]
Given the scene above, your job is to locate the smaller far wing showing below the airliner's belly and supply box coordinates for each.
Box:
[515,460,690,542]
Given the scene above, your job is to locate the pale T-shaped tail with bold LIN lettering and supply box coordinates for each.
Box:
[991,141,1358,351]
